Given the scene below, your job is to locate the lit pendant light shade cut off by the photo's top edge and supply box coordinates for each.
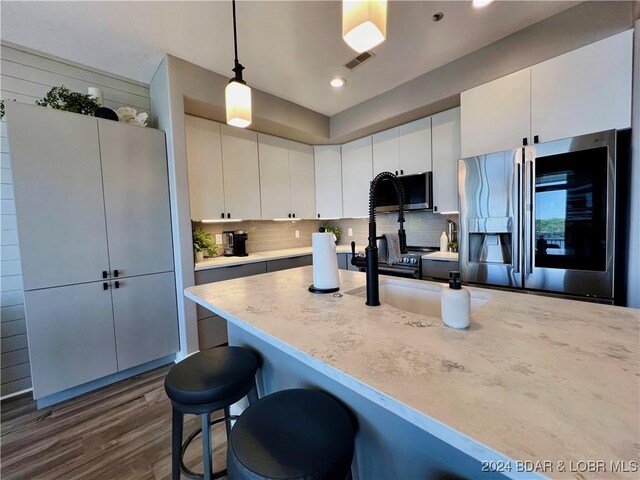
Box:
[342,0,387,53]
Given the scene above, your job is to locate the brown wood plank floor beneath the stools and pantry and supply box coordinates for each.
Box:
[0,366,226,480]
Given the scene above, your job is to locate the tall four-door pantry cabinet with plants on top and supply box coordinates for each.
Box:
[7,102,178,399]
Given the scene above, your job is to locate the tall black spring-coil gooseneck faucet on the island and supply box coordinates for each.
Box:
[351,172,407,307]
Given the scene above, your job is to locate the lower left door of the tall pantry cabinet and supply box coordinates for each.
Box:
[24,282,118,398]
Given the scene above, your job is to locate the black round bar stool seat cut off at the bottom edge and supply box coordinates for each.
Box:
[227,389,355,480]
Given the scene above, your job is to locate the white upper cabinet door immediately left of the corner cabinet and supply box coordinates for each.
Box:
[289,141,316,218]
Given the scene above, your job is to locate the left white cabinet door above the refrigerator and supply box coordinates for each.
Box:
[460,69,531,158]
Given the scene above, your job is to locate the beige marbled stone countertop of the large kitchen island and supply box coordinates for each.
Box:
[185,267,640,479]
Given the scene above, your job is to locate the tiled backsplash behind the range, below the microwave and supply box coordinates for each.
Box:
[329,212,458,251]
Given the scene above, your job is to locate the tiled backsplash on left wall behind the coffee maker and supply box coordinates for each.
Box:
[197,220,322,253]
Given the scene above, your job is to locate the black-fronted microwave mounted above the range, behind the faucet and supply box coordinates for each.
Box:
[376,172,433,212]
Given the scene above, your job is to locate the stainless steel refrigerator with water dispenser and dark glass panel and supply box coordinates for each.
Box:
[458,130,616,301]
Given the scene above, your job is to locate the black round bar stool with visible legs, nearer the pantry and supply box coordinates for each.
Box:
[164,347,258,480]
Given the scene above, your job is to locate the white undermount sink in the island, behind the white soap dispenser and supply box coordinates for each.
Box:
[345,279,489,318]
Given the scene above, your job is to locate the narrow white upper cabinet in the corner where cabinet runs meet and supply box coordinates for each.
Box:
[313,145,342,218]
